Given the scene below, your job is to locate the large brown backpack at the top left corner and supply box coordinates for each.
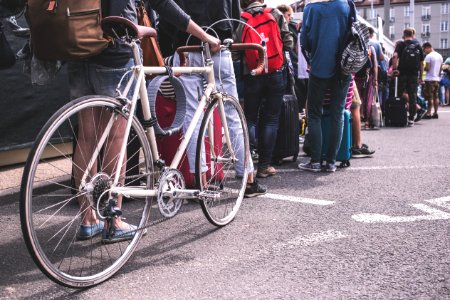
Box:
[26,0,109,60]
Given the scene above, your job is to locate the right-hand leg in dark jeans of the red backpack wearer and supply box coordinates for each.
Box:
[258,72,285,172]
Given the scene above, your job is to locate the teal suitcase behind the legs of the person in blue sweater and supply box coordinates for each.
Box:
[322,110,352,167]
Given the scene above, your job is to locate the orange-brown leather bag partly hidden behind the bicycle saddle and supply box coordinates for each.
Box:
[137,1,164,67]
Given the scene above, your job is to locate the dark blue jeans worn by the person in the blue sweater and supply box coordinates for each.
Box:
[308,74,352,163]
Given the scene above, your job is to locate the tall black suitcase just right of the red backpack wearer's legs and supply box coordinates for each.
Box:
[272,67,300,164]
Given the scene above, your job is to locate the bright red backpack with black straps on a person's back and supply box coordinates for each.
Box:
[241,8,284,73]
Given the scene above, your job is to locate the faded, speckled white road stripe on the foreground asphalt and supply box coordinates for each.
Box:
[273,229,349,250]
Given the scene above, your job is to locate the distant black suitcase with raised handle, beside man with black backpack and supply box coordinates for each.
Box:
[384,77,408,127]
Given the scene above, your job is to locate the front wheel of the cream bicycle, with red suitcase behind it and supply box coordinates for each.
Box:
[195,95,250,226]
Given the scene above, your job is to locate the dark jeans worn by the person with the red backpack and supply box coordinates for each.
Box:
[244,71,286,169]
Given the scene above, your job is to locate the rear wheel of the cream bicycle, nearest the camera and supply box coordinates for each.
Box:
[20,96,154,287]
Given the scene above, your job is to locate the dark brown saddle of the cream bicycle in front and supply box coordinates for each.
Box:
[101,16,157,39]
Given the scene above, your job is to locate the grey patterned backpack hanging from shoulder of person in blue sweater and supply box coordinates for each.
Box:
[338,0,369,75]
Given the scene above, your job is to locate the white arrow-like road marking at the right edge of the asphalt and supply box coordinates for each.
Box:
[352,204,450,223]
